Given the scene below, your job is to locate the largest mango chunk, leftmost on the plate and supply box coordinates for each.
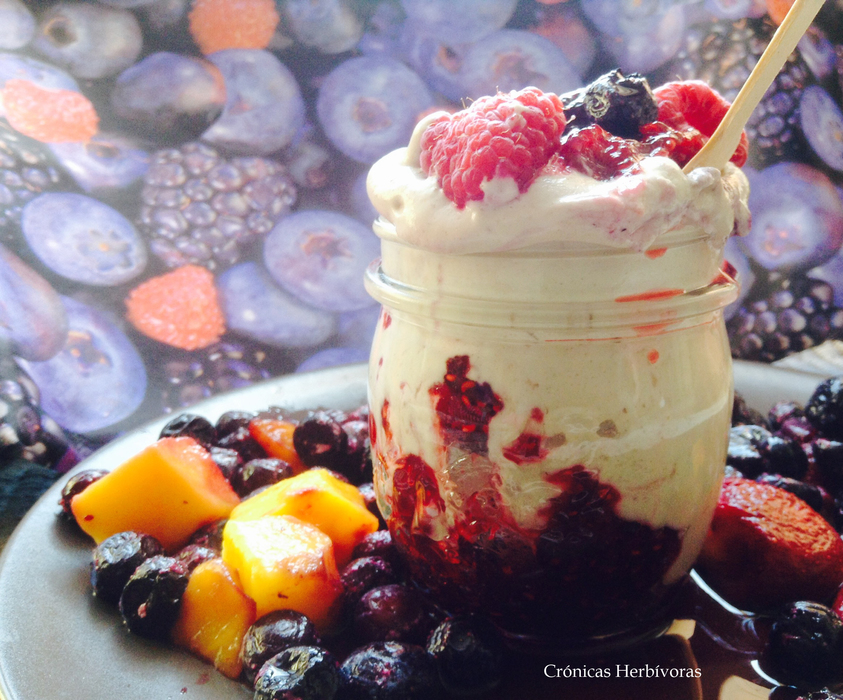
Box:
[70,437,240,551]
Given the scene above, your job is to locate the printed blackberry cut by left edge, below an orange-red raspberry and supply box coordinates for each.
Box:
[0,119,69,244]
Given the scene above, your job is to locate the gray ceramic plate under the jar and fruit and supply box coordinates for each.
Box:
[0,363,832,700]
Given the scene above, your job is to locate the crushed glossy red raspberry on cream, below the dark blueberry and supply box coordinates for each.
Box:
[548,124,641,180]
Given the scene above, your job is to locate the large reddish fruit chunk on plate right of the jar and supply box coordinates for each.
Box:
[697,477,843,611]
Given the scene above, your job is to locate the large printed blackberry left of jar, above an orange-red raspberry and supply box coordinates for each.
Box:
[138,142,296,270]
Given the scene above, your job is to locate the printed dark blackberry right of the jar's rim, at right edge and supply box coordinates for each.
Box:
[727,273,843,362]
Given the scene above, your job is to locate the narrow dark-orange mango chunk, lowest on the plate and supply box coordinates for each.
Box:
[172,559,257,679]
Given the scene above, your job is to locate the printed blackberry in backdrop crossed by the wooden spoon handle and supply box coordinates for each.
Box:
[674,18,813,168]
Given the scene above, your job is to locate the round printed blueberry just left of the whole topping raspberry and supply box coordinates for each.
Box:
[316,56,434,163]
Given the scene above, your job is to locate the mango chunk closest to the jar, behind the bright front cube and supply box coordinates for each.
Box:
[229,468,378,567]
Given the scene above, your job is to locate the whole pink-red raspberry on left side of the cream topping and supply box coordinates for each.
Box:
[421,88,566,209]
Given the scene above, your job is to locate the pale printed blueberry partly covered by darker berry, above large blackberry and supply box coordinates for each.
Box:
[202,49,305,155]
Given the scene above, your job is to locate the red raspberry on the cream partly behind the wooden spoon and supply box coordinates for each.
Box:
[653,80,749,167]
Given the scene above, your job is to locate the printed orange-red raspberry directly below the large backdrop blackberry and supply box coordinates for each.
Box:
[126,265,225,350]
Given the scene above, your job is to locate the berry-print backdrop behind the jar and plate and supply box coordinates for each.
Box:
[0,0,843,512]
